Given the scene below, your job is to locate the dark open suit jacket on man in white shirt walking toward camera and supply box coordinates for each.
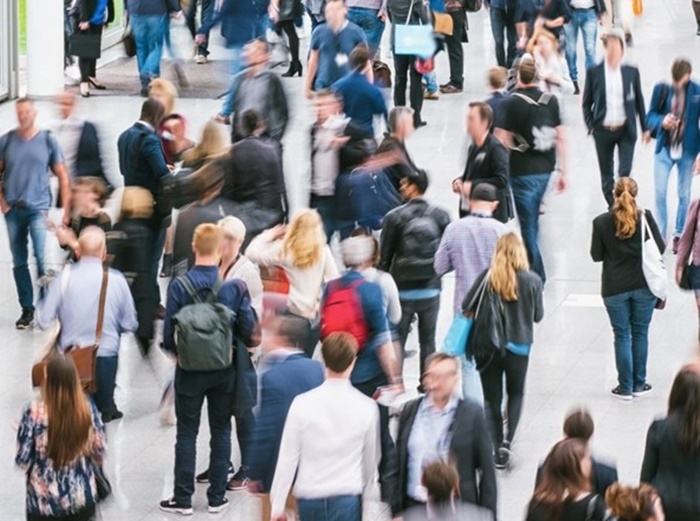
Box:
[582,61,647,140]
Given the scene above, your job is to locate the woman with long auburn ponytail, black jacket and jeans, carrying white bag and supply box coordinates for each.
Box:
[591,177,665,400]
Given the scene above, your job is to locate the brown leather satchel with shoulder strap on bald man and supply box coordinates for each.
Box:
[32,269,109,394]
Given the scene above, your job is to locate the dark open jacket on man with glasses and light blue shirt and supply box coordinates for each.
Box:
[396,398,497,517]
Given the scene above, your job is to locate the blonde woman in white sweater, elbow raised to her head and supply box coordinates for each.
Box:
[246,209,339,357]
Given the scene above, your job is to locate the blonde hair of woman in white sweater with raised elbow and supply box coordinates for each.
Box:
[282,210,326,270]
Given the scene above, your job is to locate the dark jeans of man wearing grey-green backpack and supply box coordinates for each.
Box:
[173,367,235,507]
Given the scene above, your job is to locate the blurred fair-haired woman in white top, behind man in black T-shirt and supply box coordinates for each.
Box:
[527,27,574,98]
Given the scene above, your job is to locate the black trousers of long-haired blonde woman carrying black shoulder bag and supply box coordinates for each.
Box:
[481,351,529,450]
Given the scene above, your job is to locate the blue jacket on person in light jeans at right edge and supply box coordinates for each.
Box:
[647,80,700,157]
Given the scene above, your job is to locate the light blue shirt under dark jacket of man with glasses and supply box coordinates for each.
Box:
[406,395,459,502]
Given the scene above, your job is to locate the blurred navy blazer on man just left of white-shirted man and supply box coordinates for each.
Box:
[248,353,324,492]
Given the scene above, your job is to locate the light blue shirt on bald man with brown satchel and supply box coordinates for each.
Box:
[37,257,138,356]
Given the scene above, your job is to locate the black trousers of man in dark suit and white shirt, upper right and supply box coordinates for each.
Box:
[593,127,635,207]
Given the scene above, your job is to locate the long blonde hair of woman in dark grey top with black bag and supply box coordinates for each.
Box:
[489,232,530,302]
